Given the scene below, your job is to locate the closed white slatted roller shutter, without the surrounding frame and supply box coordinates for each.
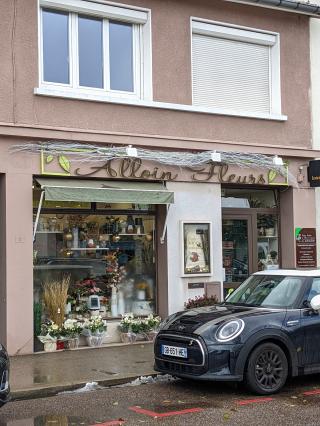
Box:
[192,34,271,113]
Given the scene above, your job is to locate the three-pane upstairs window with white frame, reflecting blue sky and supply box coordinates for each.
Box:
[40,0,151,98]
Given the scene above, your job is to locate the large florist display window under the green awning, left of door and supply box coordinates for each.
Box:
[33,191,156,346]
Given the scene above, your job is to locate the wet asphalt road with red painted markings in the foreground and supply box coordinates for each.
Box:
[0,375,320,426]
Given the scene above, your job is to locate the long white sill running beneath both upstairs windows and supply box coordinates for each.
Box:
[34,87,288,121]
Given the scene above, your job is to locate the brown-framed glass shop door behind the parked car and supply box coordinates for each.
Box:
[222,216,252,296]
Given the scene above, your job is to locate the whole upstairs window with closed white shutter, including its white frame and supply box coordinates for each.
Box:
[192,21,281,118]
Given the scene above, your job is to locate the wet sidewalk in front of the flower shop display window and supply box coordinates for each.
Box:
[10,342,156,399]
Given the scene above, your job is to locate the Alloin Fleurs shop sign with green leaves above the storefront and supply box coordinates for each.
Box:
[41,153,288,185]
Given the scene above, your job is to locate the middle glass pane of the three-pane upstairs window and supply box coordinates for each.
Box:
[78,17,103,88]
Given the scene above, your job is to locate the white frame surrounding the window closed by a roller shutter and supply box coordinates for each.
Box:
[190,17,281,118]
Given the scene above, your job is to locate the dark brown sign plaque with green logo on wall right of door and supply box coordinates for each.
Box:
[295,228,317,268]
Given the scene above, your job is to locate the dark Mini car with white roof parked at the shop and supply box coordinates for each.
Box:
[154,270,320,394]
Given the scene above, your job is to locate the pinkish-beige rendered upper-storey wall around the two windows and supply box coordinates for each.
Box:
[0,0,311,148]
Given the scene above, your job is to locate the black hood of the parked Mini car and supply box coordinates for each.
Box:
[162,304,286,334]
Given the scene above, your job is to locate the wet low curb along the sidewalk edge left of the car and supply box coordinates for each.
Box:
[10,372,159,401]
